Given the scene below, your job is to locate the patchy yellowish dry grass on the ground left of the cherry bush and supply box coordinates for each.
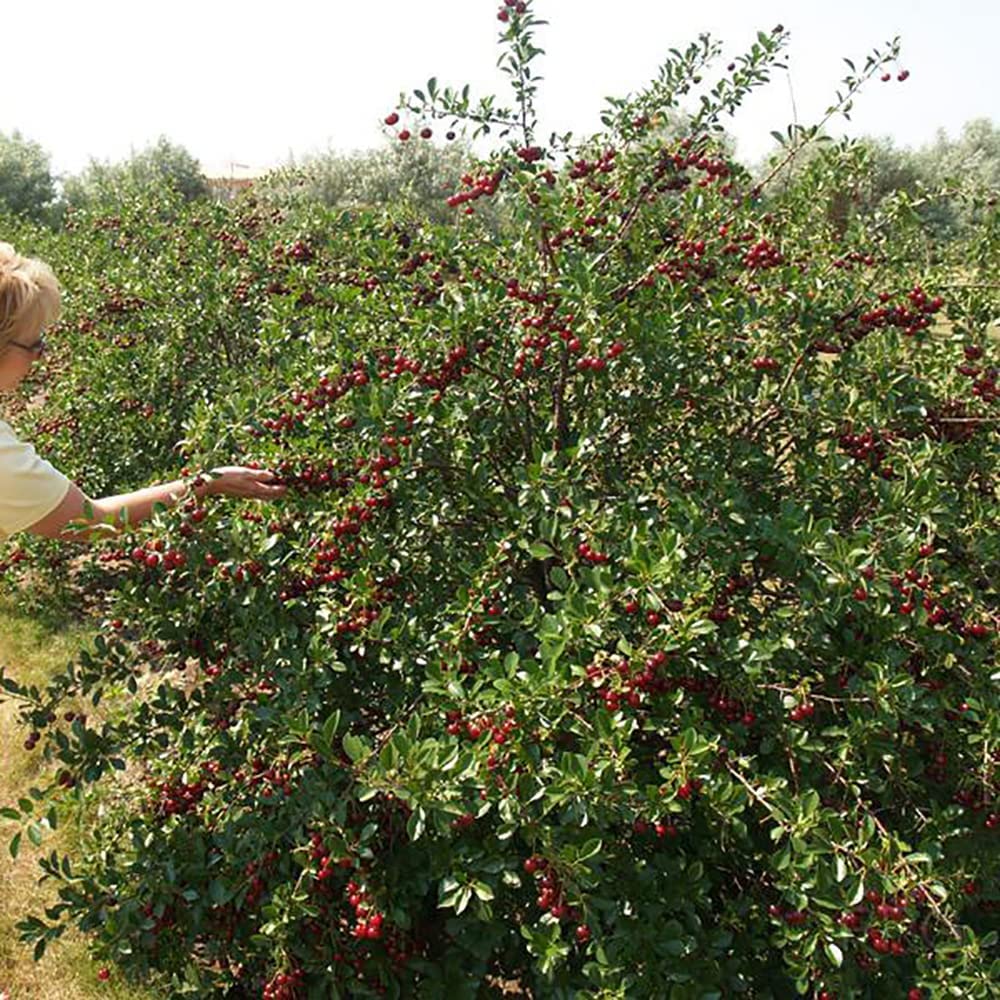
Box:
[0,598,154,1000]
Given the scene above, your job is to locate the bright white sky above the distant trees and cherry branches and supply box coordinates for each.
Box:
[0,0,1000,176]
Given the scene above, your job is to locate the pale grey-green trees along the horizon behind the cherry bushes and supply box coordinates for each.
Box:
[0,118,1000,239]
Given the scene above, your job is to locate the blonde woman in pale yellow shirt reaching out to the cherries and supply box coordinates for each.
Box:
[0,243,286,541]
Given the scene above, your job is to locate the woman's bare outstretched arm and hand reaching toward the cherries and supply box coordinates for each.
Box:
[28,466,286,542]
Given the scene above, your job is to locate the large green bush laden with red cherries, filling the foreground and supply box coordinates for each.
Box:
[3,0,1000,1000]
